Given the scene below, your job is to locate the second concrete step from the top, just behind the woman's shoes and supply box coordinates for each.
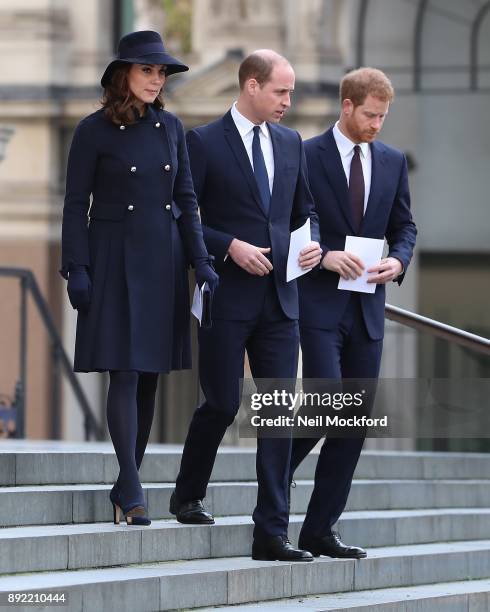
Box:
[0,480,490,527]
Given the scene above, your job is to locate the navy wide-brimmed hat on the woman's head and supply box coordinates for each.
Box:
[100,30,189,87]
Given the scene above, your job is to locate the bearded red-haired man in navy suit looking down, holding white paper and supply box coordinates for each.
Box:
[290,68,417,558]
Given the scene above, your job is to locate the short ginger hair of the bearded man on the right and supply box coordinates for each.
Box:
[340,68,395,106]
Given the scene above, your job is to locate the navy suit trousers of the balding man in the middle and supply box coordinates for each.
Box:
[176,279,299,537]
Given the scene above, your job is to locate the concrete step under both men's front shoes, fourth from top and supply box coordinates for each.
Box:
[0,540,490,612]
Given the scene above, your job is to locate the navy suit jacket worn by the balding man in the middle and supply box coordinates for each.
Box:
[187,111,320,320]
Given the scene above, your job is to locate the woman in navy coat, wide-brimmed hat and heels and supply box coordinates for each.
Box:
[61,31,218,525]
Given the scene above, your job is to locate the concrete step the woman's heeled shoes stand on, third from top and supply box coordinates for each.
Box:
[0,509,490,575]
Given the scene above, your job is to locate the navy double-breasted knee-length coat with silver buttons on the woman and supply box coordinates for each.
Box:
[61,106,207,372]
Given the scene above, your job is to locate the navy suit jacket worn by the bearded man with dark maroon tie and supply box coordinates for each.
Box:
[299,128,417,340]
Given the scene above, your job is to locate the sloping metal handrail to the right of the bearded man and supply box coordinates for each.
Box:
[385,304,490,355]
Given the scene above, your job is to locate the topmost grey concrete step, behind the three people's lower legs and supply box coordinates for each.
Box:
[0,440,490,486]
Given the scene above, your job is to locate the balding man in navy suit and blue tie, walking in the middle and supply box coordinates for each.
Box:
[170,50,321,561]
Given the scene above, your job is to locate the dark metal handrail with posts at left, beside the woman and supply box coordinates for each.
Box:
[0,267,105,440]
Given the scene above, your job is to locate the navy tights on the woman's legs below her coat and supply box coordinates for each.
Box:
[107,371,158,510]
